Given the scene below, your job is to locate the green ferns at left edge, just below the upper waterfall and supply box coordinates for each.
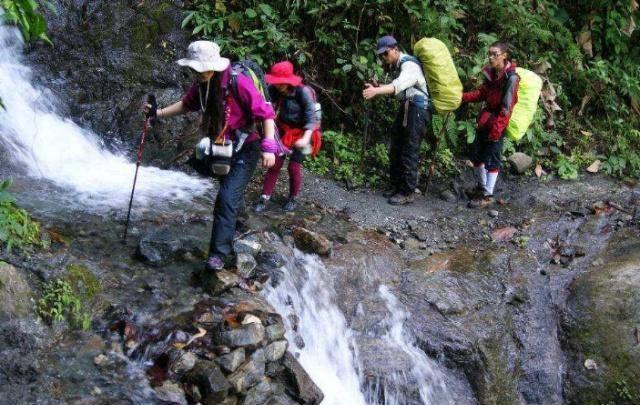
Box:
[0,180,44,251]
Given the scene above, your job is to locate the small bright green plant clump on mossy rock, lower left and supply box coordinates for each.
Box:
[36,279,91,330]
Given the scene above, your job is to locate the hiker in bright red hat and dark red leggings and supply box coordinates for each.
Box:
[254,61,321,212]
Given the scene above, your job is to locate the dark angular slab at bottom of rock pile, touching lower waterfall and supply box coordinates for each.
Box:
[274,352,324,405]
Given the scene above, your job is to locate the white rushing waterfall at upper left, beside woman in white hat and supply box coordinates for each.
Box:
[0,20,210,210]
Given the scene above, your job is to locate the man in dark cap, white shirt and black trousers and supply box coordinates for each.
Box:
[362,36,431,205]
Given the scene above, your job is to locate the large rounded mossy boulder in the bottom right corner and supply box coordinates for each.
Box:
[563,232,640,405]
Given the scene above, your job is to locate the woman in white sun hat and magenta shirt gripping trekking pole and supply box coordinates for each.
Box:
[145,41,278,271]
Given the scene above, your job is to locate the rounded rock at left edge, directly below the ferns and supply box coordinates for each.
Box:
[0,261,33,319]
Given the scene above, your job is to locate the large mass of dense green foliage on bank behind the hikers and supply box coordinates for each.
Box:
[180,0,640,181]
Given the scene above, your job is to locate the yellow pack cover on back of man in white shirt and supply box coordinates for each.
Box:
[413,38,462,114]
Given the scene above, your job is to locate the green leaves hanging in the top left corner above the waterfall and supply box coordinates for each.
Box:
[0,0,55,45]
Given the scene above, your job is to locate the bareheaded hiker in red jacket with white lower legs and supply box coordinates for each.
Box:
[462,42,520,208]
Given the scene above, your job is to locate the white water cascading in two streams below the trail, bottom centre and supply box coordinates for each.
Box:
[265,250,455,405]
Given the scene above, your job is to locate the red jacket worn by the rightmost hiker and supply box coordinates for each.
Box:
[462,62,520,141]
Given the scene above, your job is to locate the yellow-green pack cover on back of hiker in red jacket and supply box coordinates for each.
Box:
[507,67,542,141]
